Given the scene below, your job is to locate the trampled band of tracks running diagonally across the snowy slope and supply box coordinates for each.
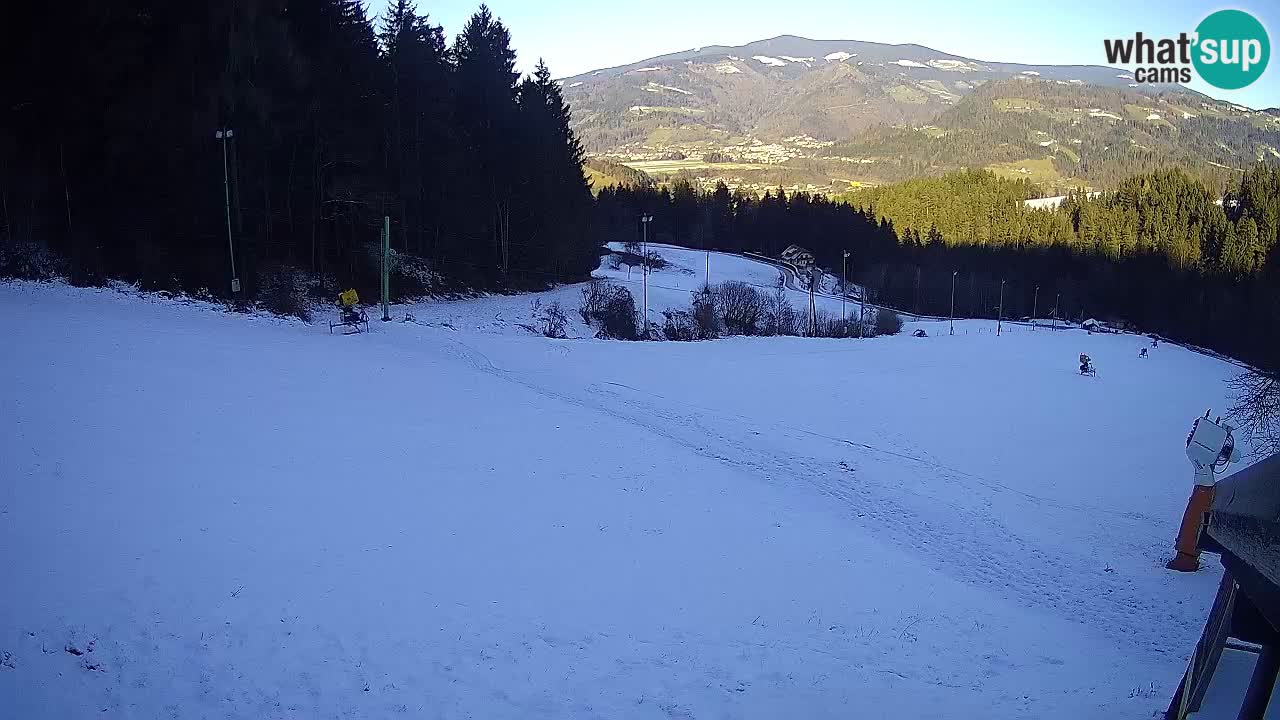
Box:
[445,330,1203,656]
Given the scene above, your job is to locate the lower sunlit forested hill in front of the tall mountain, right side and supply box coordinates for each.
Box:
[826,79,1280,195]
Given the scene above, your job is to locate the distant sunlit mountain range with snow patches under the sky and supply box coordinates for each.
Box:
[561,35,1280,192]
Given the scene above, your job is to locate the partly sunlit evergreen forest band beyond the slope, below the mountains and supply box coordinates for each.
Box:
[596,167,1280,368]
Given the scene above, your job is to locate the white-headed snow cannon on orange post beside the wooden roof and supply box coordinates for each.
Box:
[1165,410,1240,573]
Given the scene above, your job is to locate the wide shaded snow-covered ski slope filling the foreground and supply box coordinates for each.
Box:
[0,251,1236,720]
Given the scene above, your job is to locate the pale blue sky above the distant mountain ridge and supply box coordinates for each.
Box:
[369,0,1280,108]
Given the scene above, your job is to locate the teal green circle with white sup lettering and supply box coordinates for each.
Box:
[1192,10,1271,90]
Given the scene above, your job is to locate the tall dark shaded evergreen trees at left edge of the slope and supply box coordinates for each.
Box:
[0,0,598,299]
